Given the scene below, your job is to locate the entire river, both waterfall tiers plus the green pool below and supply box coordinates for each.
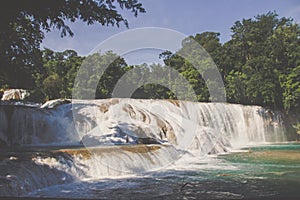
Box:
[0,99,300,199]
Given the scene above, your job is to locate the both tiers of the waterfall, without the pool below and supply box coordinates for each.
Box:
[0,99,286,193]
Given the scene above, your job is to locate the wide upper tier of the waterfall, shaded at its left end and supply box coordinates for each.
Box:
[0,99,286,150]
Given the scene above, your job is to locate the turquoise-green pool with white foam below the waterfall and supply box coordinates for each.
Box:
[22,144,300,199]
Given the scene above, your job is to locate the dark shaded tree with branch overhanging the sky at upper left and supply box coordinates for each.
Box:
[0,0,145,88]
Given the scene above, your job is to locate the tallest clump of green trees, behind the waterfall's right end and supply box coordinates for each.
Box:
[221,12,300,109]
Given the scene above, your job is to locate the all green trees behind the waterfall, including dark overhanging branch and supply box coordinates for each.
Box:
[0,7,300,113]
